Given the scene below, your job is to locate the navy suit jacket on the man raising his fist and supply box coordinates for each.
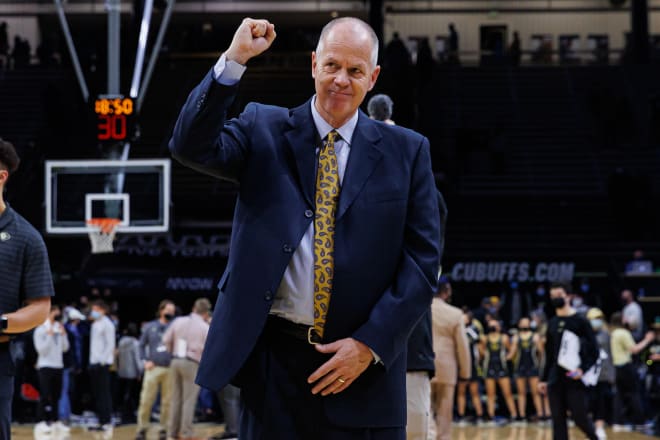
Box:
[169,70,440,427]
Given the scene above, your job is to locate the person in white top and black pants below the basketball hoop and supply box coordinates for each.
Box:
[89,299,117,437]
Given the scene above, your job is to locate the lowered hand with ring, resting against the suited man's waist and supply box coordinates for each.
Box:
[307,338,374,396]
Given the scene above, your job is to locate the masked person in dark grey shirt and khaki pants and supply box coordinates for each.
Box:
[135,299,176,440]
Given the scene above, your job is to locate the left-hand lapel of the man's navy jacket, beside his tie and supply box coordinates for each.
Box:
[284,100,318,207]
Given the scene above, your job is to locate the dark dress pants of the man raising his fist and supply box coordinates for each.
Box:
[237,326,406,440]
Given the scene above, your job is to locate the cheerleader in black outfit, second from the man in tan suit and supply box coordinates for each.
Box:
[479,319,518,424]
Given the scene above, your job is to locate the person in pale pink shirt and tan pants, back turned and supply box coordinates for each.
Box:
[163,298,211,439]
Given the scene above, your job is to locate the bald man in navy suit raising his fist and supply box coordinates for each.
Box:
[170,18,440,440]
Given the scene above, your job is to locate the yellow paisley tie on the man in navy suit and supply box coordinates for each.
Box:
[314,130,340,339]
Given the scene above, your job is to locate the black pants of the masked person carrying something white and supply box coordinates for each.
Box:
[548,378,598,440]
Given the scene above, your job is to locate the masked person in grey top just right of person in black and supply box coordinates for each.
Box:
[587,308,616,440]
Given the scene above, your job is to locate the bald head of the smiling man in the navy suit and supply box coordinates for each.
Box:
[312,23,380,128]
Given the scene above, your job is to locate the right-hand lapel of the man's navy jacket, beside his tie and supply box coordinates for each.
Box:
[336,111,383,221]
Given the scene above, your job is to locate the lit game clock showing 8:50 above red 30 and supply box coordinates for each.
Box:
[94,96,134,142]
